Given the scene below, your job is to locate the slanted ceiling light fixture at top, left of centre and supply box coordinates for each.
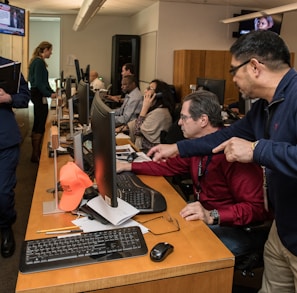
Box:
[72,0,106,31]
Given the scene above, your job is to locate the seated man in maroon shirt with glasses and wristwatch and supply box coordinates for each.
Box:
[117,91,269,256]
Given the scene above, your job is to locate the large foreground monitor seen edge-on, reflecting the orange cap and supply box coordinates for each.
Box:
[91,92,118,207]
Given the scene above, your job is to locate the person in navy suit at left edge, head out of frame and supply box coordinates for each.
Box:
[0,57,30,257]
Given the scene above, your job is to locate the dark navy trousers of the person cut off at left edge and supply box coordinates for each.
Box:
[0,145,20,228]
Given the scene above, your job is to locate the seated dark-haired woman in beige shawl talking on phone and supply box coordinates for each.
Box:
[128,79,175,152]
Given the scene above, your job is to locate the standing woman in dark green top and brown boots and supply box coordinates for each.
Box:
[28,41,57,163]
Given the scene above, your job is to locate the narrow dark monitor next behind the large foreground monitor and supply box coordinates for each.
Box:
[76,80,90,125]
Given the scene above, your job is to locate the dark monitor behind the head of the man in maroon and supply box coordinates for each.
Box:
[197,77,226,105]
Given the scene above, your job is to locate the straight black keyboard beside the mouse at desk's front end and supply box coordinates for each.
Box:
[20,226,148,273]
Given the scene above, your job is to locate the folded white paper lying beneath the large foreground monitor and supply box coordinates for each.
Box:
[87,195,139,226]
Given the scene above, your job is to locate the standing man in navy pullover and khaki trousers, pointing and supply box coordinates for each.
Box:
[148,31,297,293]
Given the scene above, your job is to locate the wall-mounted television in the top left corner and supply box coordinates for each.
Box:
[0,3,26,37]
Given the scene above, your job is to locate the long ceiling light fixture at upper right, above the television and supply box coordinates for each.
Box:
[221,3,297,23]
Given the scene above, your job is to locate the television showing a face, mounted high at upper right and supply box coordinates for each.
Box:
[238,10,283,37]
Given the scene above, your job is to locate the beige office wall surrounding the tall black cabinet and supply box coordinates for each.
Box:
[28,2,297,89]
